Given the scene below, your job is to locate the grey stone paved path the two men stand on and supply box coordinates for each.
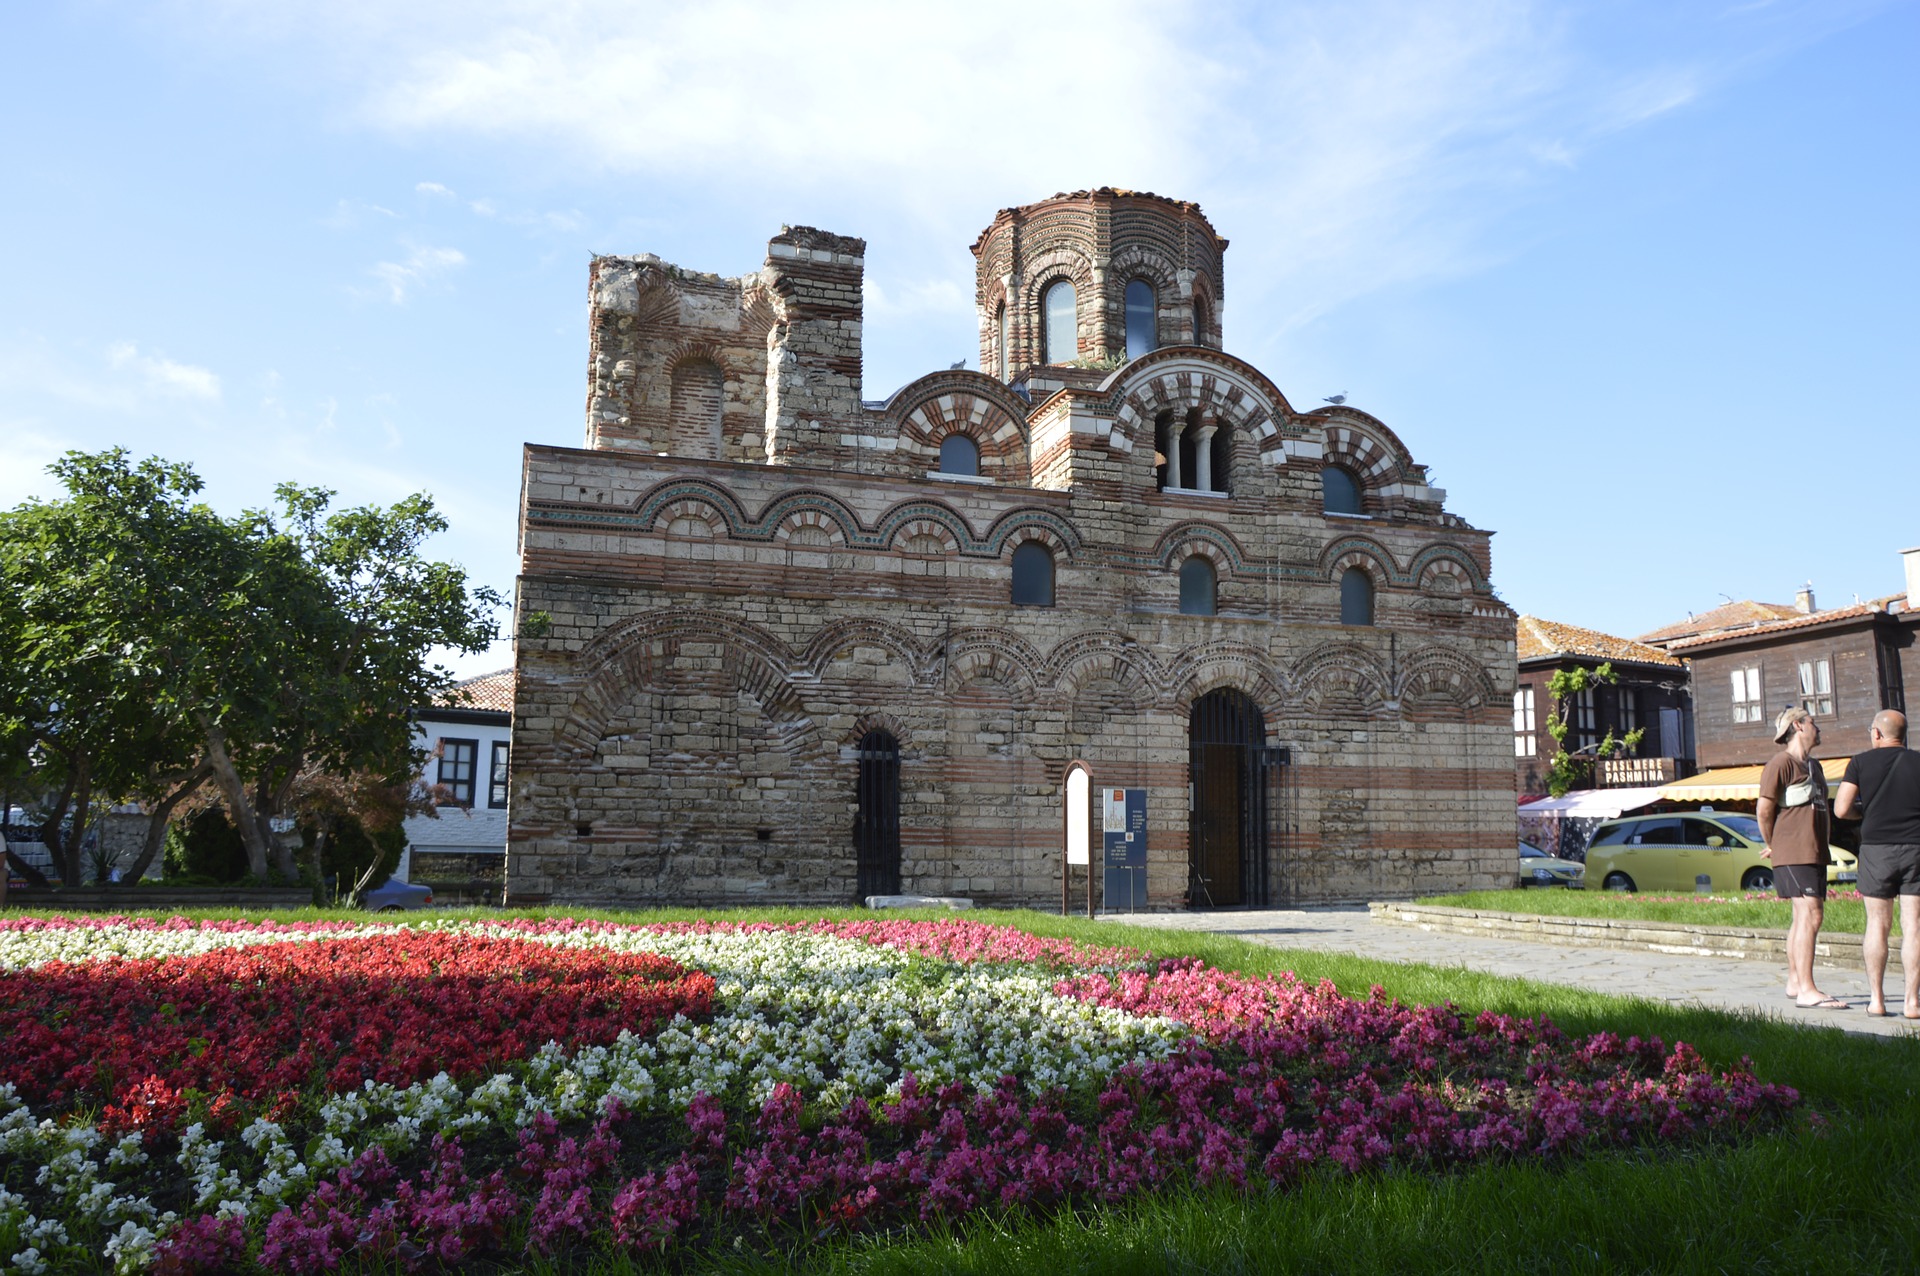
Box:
[1102,904,1920,1036]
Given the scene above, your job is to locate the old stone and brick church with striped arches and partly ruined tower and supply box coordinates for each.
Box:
[507,188,1515,908]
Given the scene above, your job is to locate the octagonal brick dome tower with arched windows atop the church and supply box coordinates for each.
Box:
[973,186,1227,384]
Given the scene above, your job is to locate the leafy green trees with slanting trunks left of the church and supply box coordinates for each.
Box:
[0,449,501,883]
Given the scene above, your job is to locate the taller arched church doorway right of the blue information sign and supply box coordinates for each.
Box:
[1187,687,1279,908]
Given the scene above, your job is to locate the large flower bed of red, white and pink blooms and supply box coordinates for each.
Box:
[0,919,1797,1272]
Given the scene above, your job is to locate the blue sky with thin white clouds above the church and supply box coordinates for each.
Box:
[0,0,1920,672]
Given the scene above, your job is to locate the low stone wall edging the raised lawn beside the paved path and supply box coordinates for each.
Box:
[1367,902,1901,973]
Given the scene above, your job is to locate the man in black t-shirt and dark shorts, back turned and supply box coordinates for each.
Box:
[1834,708,1920,1019]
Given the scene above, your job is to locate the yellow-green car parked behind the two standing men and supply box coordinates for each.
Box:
[1586,812,1859,892]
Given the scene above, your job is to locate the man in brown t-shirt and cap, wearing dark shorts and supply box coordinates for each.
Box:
[1755,708,1847,1009]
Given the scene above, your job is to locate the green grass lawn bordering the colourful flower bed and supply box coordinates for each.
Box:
[18,892,1920,1276]
